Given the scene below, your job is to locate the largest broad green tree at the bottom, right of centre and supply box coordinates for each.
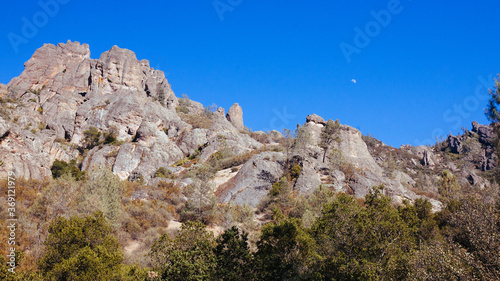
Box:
[312,187,414,280]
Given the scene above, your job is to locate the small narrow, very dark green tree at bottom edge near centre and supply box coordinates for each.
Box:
[214,226,254,281]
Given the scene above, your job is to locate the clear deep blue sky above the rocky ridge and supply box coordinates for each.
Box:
[0,0,500,144]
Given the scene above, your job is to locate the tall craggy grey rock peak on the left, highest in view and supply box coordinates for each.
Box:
[0,41,184,178]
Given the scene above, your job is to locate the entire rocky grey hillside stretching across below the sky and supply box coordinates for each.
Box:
[0,41,496,209]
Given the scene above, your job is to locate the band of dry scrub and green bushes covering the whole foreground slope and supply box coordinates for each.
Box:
[0,154,500,280]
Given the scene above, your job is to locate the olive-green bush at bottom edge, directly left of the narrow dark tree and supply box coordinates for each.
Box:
[148,222,217,281]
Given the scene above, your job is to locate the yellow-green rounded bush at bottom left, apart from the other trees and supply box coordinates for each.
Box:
[38,212,123,281]
